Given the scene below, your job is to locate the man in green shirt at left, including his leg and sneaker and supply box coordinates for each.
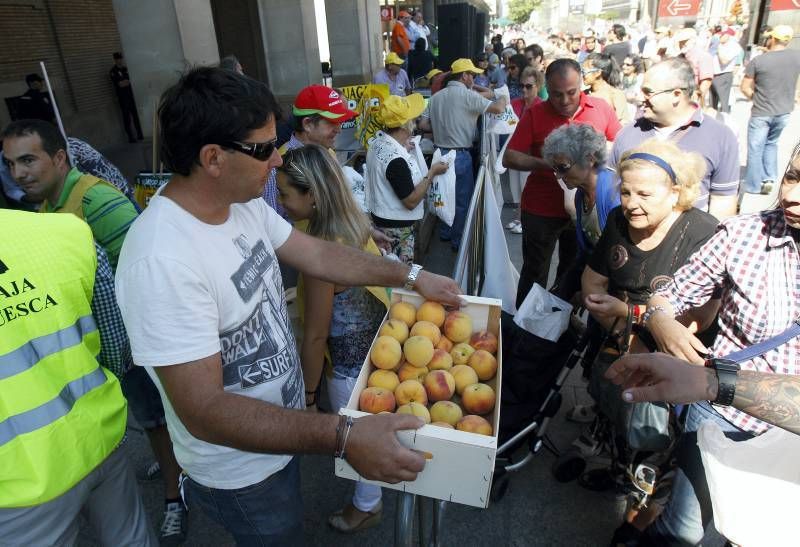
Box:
[3,120,186,541]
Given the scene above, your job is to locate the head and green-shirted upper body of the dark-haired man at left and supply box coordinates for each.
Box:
[1,120,137,268]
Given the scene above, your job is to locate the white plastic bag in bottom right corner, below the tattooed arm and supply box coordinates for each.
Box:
[697,422,800,547]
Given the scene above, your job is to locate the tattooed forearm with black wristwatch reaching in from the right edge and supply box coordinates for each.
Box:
[606,353,800,435]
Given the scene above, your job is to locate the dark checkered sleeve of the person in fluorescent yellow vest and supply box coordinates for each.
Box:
[92,243,133,380]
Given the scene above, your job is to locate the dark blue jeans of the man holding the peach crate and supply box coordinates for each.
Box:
[183,457,305,546]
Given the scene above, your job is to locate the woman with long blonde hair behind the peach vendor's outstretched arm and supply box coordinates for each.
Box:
[277,144,389,532]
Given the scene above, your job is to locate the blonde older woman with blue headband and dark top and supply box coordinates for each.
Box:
[581,139,717,334]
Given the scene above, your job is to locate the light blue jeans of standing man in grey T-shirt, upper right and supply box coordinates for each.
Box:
[744,114,789,194]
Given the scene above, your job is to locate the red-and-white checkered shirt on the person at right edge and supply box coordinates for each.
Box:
[658,209,800,434]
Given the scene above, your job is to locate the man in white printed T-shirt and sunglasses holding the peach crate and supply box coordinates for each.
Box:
[116,67,461,545]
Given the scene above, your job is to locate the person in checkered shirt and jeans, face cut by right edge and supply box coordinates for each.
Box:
[645,145,800,544]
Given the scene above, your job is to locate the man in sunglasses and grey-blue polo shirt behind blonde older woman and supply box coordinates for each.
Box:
[610,58,739,220]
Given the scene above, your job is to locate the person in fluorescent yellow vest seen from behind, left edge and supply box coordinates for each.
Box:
[0,210,156,545]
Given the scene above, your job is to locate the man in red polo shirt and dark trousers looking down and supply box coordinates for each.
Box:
[503,59,620,306]
